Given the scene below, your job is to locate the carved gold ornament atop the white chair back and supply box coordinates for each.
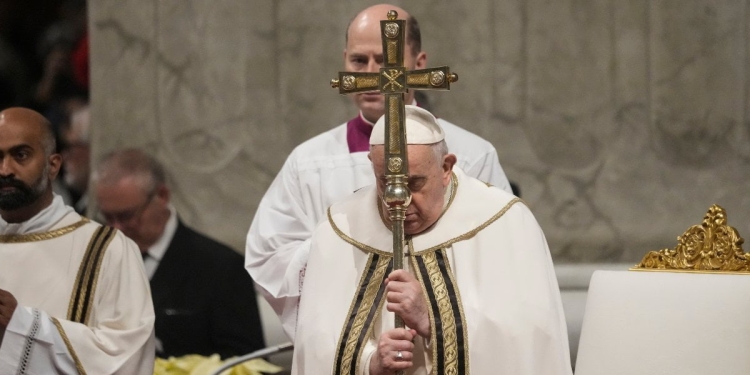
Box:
[631,205,750,273]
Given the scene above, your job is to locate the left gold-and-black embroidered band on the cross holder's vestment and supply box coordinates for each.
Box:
[333,253,393,375]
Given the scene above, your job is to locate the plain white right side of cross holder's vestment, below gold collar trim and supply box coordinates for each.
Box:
[451,203,572,375]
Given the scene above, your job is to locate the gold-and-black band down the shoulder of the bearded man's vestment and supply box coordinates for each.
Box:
[68,226,117,324]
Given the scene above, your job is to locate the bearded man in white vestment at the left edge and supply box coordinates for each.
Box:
[0,108,155,375]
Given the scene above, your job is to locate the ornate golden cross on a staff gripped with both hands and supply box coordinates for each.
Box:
[331,10,458,334]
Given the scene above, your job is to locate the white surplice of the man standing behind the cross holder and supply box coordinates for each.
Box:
[245,119,511,338]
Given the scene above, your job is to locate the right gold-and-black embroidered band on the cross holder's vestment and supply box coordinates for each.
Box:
[409,247,470,375]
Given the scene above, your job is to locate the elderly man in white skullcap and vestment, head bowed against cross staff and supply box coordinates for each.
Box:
[292,106,571,375]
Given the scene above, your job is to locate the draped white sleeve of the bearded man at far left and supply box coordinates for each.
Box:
[0,232,155,375]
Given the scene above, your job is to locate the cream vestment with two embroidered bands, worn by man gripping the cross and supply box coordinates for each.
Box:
[292,168,571,375]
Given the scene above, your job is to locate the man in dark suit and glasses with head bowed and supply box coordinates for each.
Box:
[94,149,264,358]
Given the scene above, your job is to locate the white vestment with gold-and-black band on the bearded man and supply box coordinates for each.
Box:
[0,196,155,375]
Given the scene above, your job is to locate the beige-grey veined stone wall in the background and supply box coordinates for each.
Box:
[89,0,750,262]
